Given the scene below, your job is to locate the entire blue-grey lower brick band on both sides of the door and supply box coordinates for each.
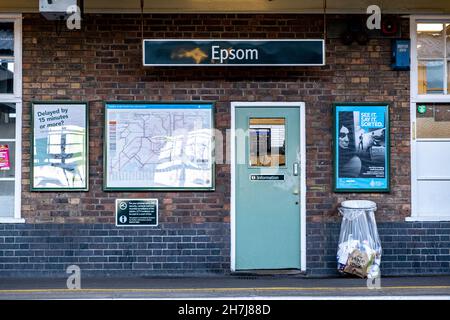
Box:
[0,222,450,277]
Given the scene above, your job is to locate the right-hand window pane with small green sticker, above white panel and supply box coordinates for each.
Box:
[416,103,450,138]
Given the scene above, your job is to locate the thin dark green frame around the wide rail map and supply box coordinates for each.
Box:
[103,100,216,191]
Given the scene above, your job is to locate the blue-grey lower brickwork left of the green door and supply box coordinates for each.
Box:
[0,223,230,277]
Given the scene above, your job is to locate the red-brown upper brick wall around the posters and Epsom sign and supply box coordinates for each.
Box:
[22,14,410,223]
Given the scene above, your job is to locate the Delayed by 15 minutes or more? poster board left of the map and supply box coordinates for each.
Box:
[31,101,89,191]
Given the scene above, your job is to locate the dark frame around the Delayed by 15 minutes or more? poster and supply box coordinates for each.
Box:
[30,100,89,192]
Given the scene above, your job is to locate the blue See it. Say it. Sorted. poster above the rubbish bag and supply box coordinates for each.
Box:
[334,104,389,192]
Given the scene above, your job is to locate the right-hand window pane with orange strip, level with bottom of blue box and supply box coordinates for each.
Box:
[417,60,444,94]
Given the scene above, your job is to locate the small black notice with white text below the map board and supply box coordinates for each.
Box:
[116,199,158,227]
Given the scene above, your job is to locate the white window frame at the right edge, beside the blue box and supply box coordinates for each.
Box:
[405,15,450,221]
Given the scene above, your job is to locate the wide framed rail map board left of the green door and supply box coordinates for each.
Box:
[104,102,214,191]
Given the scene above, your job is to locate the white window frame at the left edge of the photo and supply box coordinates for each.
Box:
[0,14,25,223]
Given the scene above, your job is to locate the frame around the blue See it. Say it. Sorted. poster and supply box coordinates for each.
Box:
[332,102,391,193]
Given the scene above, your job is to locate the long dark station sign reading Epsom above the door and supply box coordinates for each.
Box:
[142,39,325,66]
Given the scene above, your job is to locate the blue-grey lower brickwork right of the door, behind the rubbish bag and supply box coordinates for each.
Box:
[306,222,450,276]
